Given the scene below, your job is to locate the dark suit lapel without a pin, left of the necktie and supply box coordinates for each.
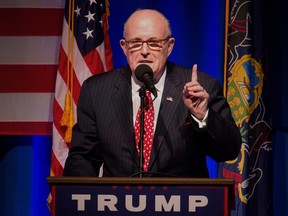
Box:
[112,66,139,166]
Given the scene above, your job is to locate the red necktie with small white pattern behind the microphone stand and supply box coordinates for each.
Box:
[134,91,154,171]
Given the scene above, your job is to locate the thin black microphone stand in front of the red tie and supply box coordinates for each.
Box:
[138,86,146,178]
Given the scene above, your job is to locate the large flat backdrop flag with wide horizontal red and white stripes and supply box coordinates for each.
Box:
[0,0,64,135]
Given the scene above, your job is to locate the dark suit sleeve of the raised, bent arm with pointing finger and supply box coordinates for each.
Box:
[195,76,241,162]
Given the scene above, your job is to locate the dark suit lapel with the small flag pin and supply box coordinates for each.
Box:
[148,64,183,170]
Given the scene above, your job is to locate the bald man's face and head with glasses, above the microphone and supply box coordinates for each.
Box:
[120,10,174,78]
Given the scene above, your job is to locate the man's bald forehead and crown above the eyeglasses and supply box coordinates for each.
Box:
[125,11,168,40]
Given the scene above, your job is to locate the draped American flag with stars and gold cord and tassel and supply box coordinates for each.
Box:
[51,0,113,176]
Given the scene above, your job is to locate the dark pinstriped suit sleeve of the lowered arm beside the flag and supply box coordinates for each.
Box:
[63,78,102,176]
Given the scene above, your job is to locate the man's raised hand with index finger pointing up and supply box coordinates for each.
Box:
[182,64,209,120]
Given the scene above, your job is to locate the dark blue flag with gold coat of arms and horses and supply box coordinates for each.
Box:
[218,0,273,216]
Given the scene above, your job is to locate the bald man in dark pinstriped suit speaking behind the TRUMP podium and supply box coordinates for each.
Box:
[64,10,241,177]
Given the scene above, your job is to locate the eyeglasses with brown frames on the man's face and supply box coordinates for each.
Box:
[125,37,170,51]
